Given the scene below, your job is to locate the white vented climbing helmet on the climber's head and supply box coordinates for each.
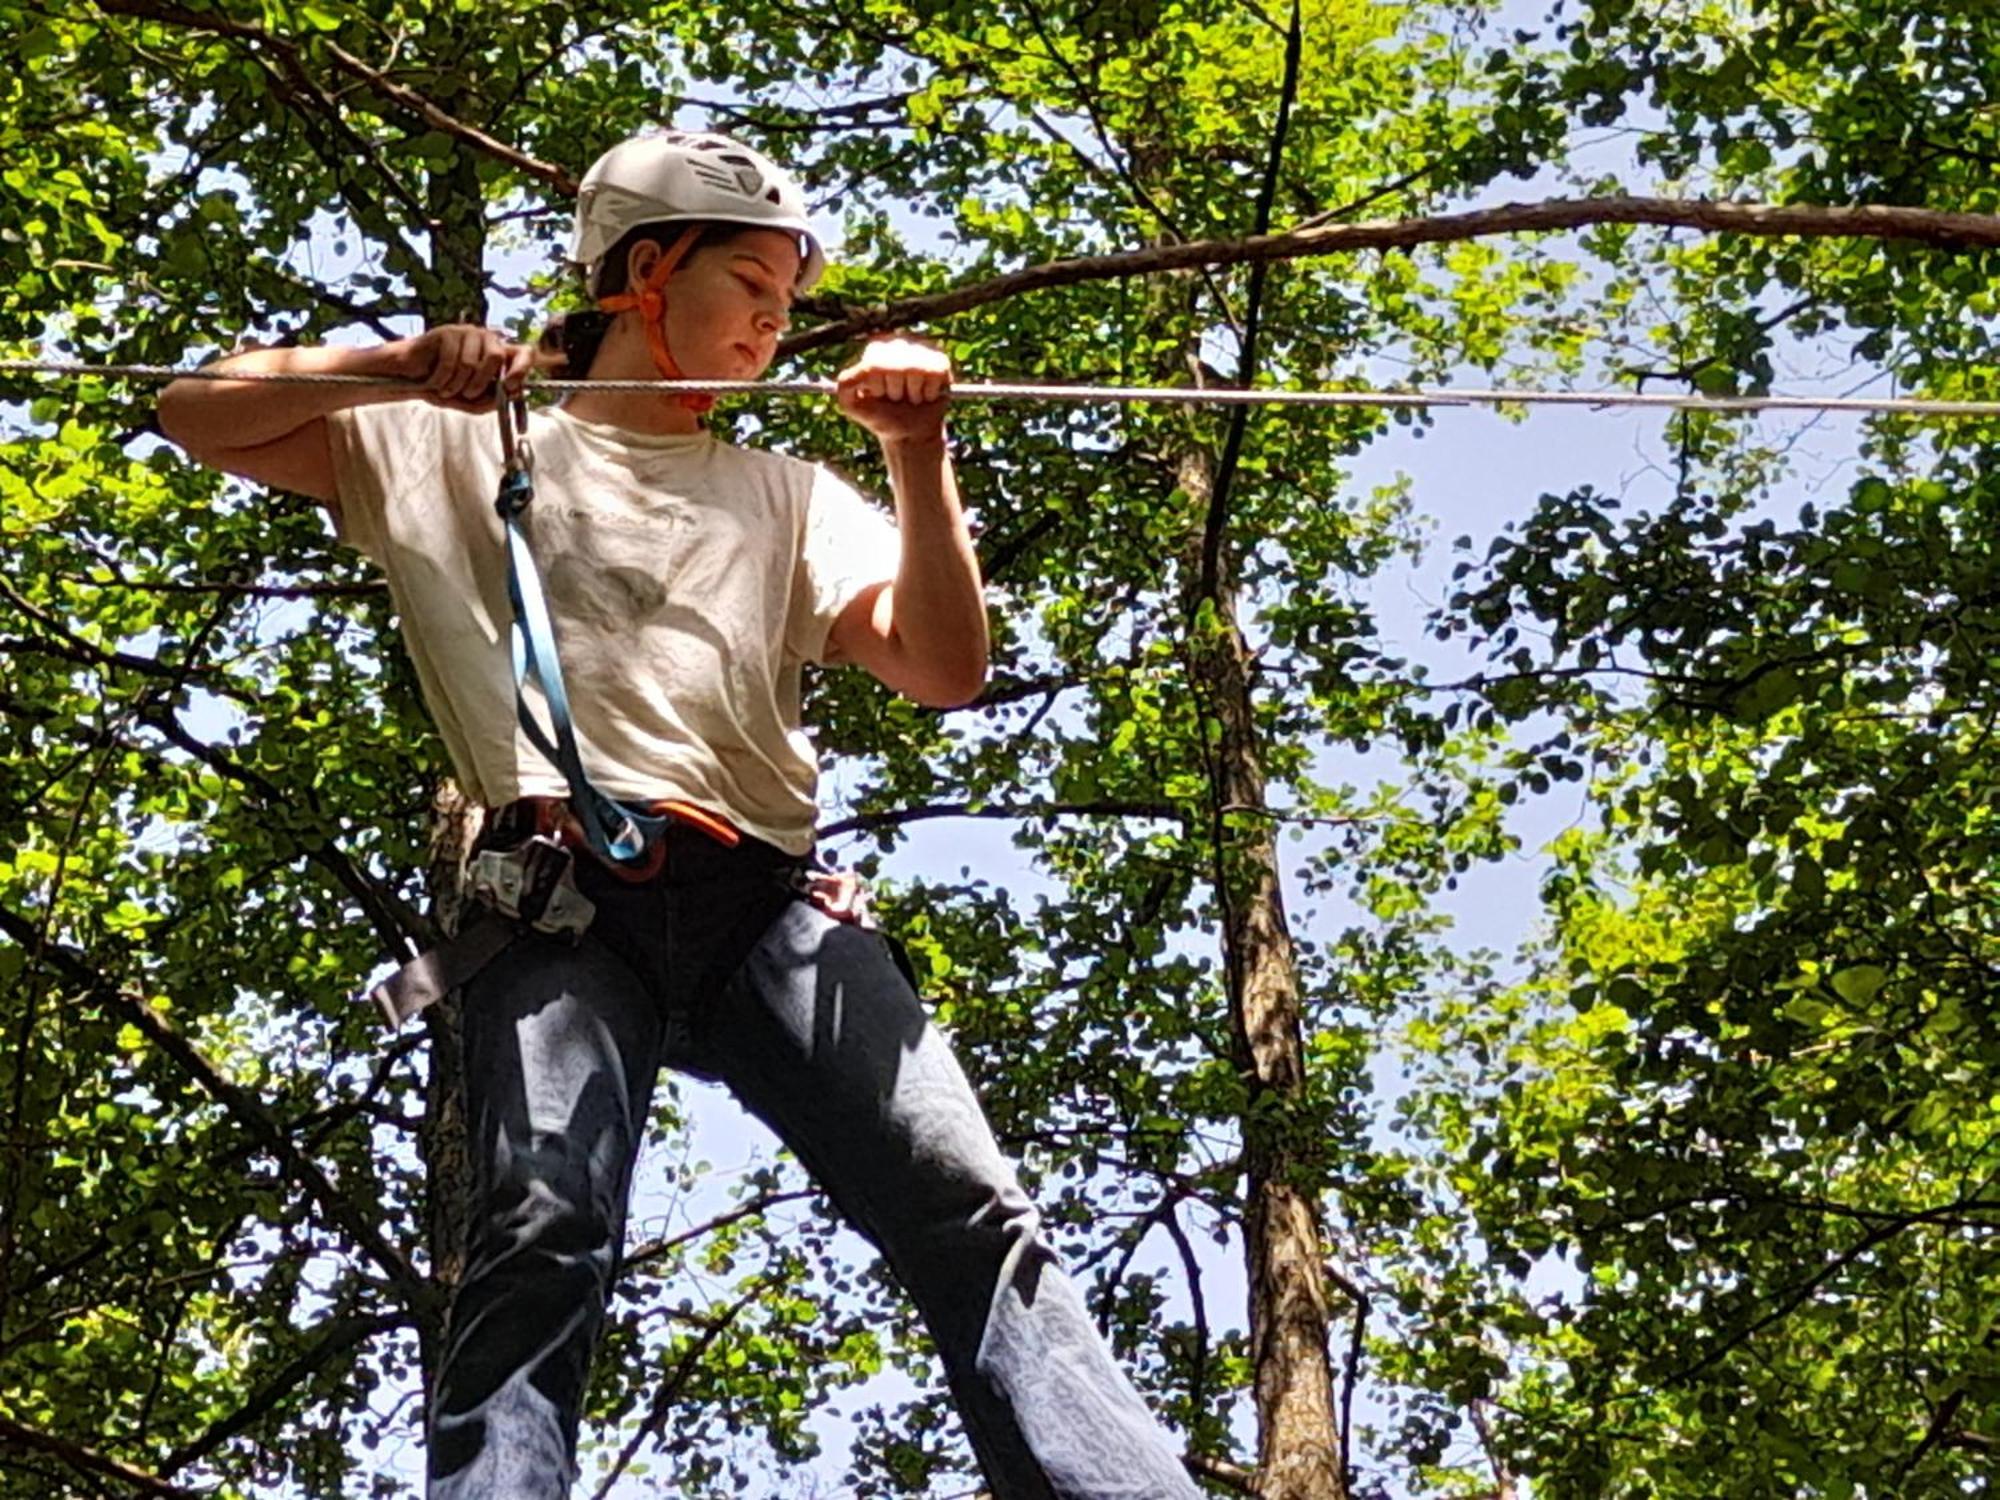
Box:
[570,130,826,292]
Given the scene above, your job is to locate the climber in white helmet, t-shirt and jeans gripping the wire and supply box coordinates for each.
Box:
[160,132,1196,1500]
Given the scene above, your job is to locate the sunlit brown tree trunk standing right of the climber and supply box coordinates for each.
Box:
[1176,440,1346,1500]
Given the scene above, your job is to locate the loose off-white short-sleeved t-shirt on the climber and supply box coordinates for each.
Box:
[326,400,900,854]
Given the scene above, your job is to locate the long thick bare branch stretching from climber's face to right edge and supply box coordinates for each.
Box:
[778,196,2000,354]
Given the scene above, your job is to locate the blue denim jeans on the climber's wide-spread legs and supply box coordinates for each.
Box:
[430,830,1198,1500]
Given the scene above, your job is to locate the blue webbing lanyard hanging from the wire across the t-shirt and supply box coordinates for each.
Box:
[494,390,668,864]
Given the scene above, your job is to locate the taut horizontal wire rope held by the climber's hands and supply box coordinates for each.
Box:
[0,360,2000,418]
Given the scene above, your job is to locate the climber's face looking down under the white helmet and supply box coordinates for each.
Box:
[632,230,802,380]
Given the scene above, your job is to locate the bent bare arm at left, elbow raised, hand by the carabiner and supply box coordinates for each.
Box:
[160,326,534,506]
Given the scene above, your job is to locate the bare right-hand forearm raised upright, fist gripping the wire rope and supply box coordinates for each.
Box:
[828,340,988,708]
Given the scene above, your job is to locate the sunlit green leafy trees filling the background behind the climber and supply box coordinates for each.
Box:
[0,0,2000,1500]
